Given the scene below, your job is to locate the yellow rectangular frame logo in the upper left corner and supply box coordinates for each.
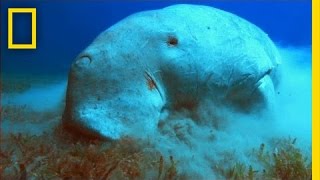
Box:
[8,8,37,49]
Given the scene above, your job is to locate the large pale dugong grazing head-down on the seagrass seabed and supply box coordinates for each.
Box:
[62,4,281,140]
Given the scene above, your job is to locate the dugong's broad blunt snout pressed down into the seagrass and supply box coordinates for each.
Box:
[64,52,164,139]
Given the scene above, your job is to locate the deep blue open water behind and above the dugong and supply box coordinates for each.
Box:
[1,0,311,73]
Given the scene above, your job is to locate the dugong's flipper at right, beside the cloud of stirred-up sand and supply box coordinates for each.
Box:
[226,67,279,114]
